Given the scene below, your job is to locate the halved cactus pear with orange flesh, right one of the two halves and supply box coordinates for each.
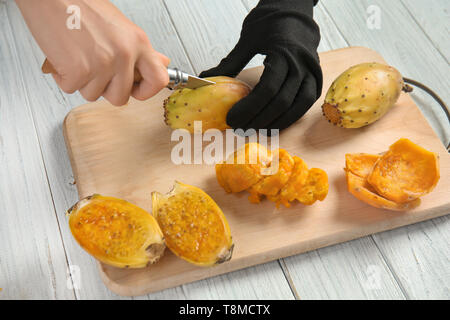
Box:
[152,181,234,266]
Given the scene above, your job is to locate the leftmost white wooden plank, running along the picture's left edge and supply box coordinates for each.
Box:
[0,2,74,300]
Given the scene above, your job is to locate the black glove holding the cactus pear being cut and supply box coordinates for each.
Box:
[200,0,322,130]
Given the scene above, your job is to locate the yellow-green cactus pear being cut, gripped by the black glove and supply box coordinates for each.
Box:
[164,76,251,133]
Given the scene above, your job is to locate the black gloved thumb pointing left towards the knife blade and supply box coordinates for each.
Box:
[200,41,254,78]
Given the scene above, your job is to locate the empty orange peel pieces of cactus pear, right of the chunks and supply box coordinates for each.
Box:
[345,139,439,211]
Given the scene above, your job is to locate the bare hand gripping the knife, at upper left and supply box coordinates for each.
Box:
[16,0,169,105]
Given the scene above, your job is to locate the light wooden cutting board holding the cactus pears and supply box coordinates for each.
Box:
[64,47,450,295]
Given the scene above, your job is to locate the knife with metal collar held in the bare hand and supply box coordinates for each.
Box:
[41,59,215,90]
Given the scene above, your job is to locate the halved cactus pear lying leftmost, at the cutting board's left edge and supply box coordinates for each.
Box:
[67,194,165,268]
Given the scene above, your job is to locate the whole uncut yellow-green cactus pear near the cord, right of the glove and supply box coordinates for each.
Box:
[322,62,410,128]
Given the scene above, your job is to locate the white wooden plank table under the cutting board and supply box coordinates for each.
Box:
[0,0,450,299]
